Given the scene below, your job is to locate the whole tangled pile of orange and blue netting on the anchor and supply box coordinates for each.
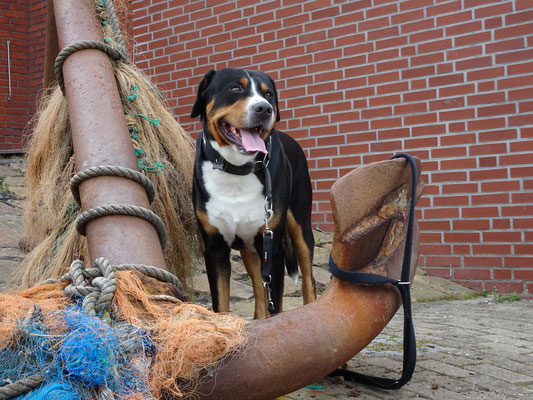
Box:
[0,271,246,400]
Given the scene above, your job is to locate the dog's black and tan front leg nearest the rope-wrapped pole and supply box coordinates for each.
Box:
[204,239,231,313]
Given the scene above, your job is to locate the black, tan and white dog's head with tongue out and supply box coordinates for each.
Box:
[191,68,279,154]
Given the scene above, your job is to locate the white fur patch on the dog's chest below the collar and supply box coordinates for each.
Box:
[202,161,265,249]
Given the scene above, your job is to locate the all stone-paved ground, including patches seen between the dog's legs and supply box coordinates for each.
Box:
[0,158,533,400]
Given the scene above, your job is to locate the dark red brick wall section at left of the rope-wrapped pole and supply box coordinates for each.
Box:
[0,0,46,152]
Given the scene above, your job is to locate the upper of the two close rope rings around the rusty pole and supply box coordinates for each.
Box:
[69,165,155,204]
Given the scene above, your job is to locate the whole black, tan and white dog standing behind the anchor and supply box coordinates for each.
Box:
[191,68,316,319]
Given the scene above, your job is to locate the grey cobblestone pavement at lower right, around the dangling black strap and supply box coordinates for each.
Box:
[286,297,533,400]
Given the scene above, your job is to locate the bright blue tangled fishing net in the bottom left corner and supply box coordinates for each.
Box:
[0,306,155,400]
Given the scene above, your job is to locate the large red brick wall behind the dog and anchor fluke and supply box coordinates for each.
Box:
[137,0,533,295]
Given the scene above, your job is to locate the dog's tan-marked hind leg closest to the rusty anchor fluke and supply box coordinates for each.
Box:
[287,210,316,304]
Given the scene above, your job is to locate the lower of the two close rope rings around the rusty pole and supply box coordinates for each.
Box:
[75,204,167,249]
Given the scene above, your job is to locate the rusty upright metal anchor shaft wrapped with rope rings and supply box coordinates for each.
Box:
[53,0,166,269]
